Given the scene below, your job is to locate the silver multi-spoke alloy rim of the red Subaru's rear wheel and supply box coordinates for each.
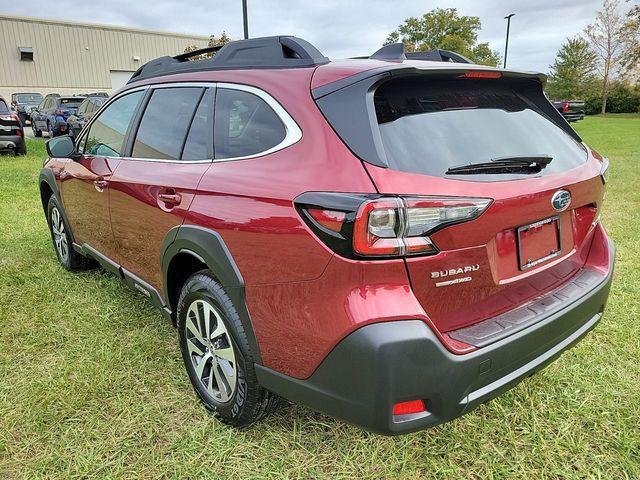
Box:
[185,300,238,403]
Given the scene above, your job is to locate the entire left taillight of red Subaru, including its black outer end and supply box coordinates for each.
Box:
[295,193,491,258]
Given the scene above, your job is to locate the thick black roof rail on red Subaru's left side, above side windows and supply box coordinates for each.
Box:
[127,36,329,83]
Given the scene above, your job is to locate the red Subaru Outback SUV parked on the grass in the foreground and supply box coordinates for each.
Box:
[40,36,614,434]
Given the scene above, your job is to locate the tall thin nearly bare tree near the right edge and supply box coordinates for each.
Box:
[585,0,628,115]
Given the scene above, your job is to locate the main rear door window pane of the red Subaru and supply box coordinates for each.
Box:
[132,87,203,160]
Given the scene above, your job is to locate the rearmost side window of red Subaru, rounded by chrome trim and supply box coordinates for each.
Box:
[214,88,286,159]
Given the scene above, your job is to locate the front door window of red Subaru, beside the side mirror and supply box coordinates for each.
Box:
[84,91,144,157]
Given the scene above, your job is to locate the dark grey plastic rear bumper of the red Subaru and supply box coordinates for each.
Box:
[256,241,614,435]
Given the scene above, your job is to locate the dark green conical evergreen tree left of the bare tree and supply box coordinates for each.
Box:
[547,36,598,99]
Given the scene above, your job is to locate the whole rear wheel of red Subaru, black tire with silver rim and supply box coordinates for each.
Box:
[177,270,280,427]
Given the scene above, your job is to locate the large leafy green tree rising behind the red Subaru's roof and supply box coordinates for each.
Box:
[384,8,500,66]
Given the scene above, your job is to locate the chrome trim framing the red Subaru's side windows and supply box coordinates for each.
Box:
[77,82,302,164]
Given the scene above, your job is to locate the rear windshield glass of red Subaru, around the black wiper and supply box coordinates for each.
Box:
[374,78,587,180]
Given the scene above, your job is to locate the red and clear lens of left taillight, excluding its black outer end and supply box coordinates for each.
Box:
[353,197,491,256]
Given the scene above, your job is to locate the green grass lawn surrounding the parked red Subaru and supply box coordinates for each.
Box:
[0,116,640,480]
